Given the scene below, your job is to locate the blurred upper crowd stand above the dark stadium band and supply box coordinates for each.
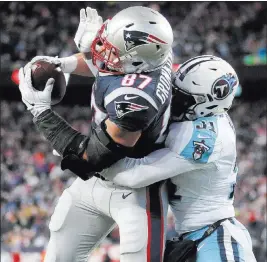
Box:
[0,1,267,68]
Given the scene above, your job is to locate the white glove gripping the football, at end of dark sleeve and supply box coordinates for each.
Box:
[19,67,55,117]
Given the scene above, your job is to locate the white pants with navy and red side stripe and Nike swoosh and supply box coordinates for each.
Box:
[45,177,168,262]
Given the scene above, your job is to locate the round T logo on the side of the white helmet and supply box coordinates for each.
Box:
[214,74,237,100]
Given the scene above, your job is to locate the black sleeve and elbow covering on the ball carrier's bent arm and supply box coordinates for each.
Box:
[34,109,131,179]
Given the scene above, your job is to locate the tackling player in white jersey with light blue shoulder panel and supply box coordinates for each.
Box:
[98,55,256,262]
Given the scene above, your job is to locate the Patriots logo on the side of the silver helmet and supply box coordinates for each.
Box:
[123,30,167,52]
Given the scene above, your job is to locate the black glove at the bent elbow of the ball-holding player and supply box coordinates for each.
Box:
[61,154,95,181]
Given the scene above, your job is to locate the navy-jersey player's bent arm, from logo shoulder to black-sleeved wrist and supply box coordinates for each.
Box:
[34,87,157,177]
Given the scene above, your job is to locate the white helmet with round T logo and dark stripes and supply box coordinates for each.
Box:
[172,55,239,121]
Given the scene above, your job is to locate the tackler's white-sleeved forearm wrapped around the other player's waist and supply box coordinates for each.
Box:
[102,148,204,188]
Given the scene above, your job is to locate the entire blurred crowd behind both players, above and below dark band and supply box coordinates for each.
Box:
[0,2,267,262]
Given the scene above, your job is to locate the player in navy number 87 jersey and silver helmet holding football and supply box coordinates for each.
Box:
[19,6,173,262]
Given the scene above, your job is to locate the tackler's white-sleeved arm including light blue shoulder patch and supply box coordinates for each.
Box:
[101,122,221,188]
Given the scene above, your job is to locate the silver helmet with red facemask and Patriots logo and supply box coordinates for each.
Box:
[91,6,173,74]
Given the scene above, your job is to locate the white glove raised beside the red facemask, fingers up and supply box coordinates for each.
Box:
[74,7,103,53]
